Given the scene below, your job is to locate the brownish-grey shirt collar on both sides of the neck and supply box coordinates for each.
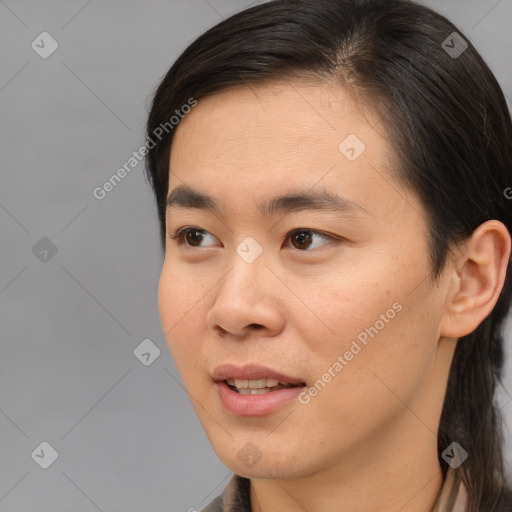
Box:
[201,466,467,512]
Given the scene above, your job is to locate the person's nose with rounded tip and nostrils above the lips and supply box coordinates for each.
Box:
[206,254,285,338]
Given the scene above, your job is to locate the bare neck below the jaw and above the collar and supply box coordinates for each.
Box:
[250,423,443,512]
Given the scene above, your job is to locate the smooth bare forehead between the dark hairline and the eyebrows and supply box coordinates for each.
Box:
[169,82,410,221]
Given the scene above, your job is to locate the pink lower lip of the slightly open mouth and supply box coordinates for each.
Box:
[216,381,304,416]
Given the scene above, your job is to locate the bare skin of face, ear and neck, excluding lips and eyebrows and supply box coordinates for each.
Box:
[158,81,510,512]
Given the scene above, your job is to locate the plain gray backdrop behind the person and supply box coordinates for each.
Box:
[0,0,512,512]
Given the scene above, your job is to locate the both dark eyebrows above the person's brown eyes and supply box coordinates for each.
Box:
[166,185,371,215]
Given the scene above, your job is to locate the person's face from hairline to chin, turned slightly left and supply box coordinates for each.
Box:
[158,82,454,478]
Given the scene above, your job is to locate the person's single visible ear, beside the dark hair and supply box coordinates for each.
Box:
[440,220,511,338]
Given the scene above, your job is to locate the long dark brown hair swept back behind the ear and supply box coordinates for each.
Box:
[146,0,512,512]
